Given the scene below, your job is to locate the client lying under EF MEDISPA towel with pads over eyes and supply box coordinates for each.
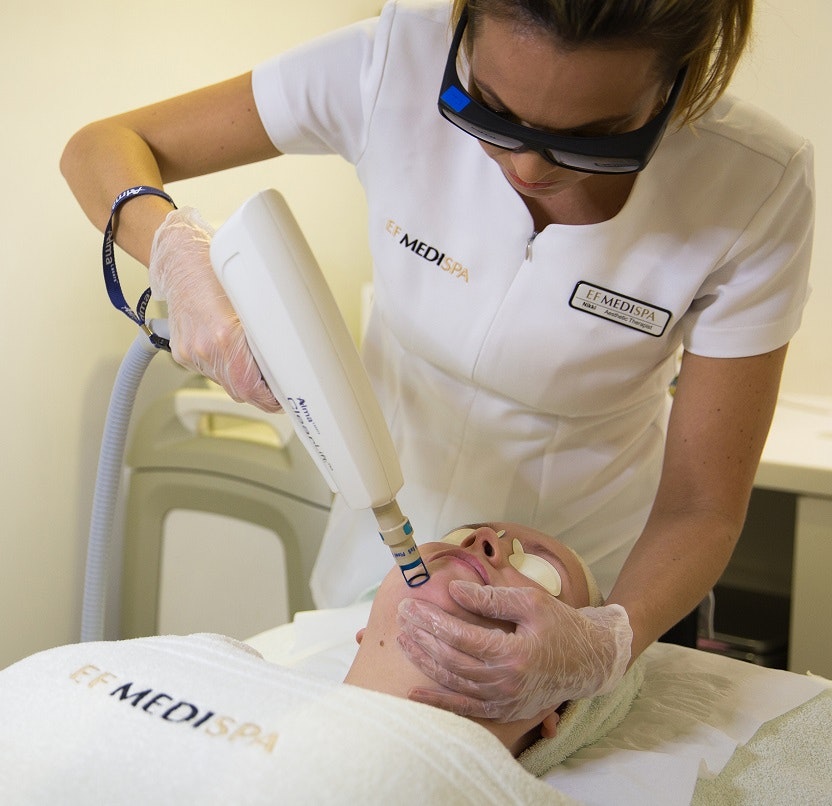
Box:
[0,524,641,803]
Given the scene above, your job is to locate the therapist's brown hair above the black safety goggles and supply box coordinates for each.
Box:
[452,0,754,122]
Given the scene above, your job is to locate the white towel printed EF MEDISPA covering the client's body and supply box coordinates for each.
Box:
[0,635,576,806]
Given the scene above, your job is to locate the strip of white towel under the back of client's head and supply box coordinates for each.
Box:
[518,658,644,776]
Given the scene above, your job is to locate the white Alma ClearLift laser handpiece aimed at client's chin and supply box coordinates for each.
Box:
[211,190,430,587]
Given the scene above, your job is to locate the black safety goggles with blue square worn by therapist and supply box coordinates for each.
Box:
[439,9,687,174]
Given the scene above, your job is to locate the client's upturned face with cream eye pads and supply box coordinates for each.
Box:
[373,523,589,629]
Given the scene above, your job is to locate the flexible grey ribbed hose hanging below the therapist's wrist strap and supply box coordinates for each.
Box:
[81,323,166,641]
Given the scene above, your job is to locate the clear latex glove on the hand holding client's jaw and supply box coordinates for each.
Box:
[398,580,633,722]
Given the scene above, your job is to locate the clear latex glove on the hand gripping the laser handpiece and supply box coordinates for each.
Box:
[149,207,280,411]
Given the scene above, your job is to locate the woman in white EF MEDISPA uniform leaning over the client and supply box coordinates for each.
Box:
[62,0,813,719]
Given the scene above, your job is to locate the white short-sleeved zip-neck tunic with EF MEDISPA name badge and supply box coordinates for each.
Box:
[253,0,813,607]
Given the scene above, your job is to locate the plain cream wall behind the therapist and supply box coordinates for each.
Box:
[0,0,832,667]
